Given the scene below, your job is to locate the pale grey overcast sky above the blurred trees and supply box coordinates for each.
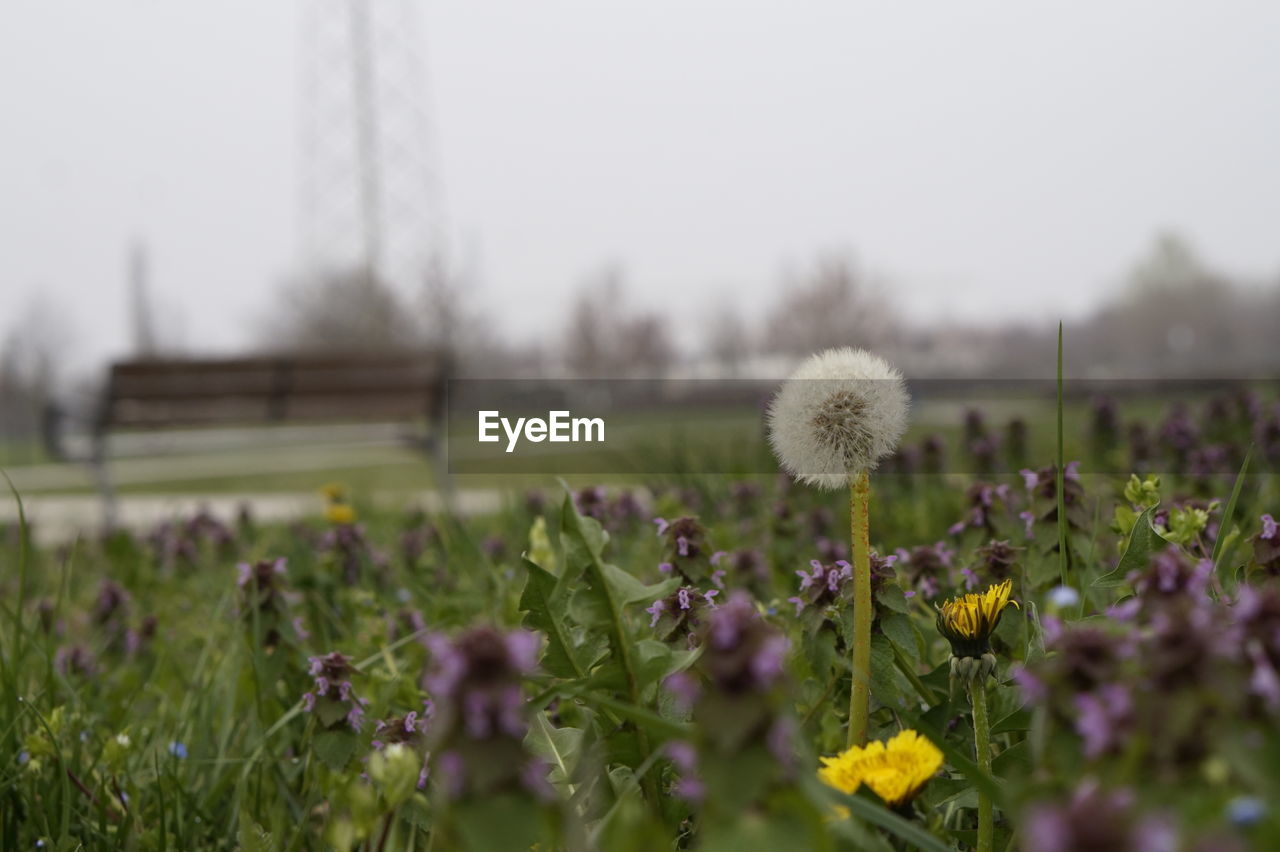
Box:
[0,0,1280,362]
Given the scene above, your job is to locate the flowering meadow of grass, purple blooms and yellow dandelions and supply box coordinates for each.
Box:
[0,378,1280,852]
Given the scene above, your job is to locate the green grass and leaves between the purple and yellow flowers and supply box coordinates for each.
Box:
[0,388,1280,852]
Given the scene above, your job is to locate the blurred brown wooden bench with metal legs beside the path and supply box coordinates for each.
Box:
[74,352,451,527]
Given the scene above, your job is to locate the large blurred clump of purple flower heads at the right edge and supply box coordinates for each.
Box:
[1014,539,1280,770]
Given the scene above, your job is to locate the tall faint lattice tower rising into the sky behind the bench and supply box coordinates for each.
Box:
[298,0,443,293]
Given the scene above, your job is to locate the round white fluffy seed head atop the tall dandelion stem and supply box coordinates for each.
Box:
[768,347,911,489]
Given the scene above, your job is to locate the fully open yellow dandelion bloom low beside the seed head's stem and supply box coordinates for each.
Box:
[818,729,942,807]
